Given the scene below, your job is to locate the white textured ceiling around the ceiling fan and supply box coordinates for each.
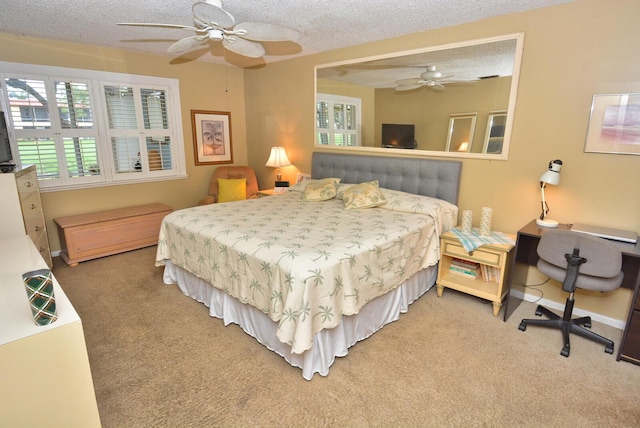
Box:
[0,0,572,67]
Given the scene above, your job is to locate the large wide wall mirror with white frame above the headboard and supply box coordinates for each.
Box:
[315,33,524,160]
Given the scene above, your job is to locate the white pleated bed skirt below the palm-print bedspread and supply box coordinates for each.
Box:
[163,261,437,380]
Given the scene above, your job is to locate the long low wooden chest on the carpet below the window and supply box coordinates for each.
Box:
[54,204,172,266]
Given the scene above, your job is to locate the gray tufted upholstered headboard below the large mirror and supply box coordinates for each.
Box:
[311,152,462,205]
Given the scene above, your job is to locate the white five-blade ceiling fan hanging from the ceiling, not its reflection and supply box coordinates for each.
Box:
[118,0,300,58]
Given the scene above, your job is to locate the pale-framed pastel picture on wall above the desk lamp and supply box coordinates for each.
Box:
[584,94,640,155]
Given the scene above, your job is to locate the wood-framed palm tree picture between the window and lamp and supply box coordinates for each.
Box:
[191,110,233,165]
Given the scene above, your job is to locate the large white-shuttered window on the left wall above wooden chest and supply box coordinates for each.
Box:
[0,62,186,190]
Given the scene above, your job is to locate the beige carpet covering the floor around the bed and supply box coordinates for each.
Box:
[54,247,640,428]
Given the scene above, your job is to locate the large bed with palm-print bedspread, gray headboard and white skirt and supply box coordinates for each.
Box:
[156,152,462,380]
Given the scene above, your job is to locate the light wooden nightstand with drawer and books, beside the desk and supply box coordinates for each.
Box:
[436,232,513,317]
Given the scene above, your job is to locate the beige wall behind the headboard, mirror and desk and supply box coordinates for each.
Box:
[245,0,640,319]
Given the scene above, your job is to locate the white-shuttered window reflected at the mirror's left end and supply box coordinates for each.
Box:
[316,94,361,146]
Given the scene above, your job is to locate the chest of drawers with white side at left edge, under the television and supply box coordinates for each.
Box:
[0,165,53,267]
